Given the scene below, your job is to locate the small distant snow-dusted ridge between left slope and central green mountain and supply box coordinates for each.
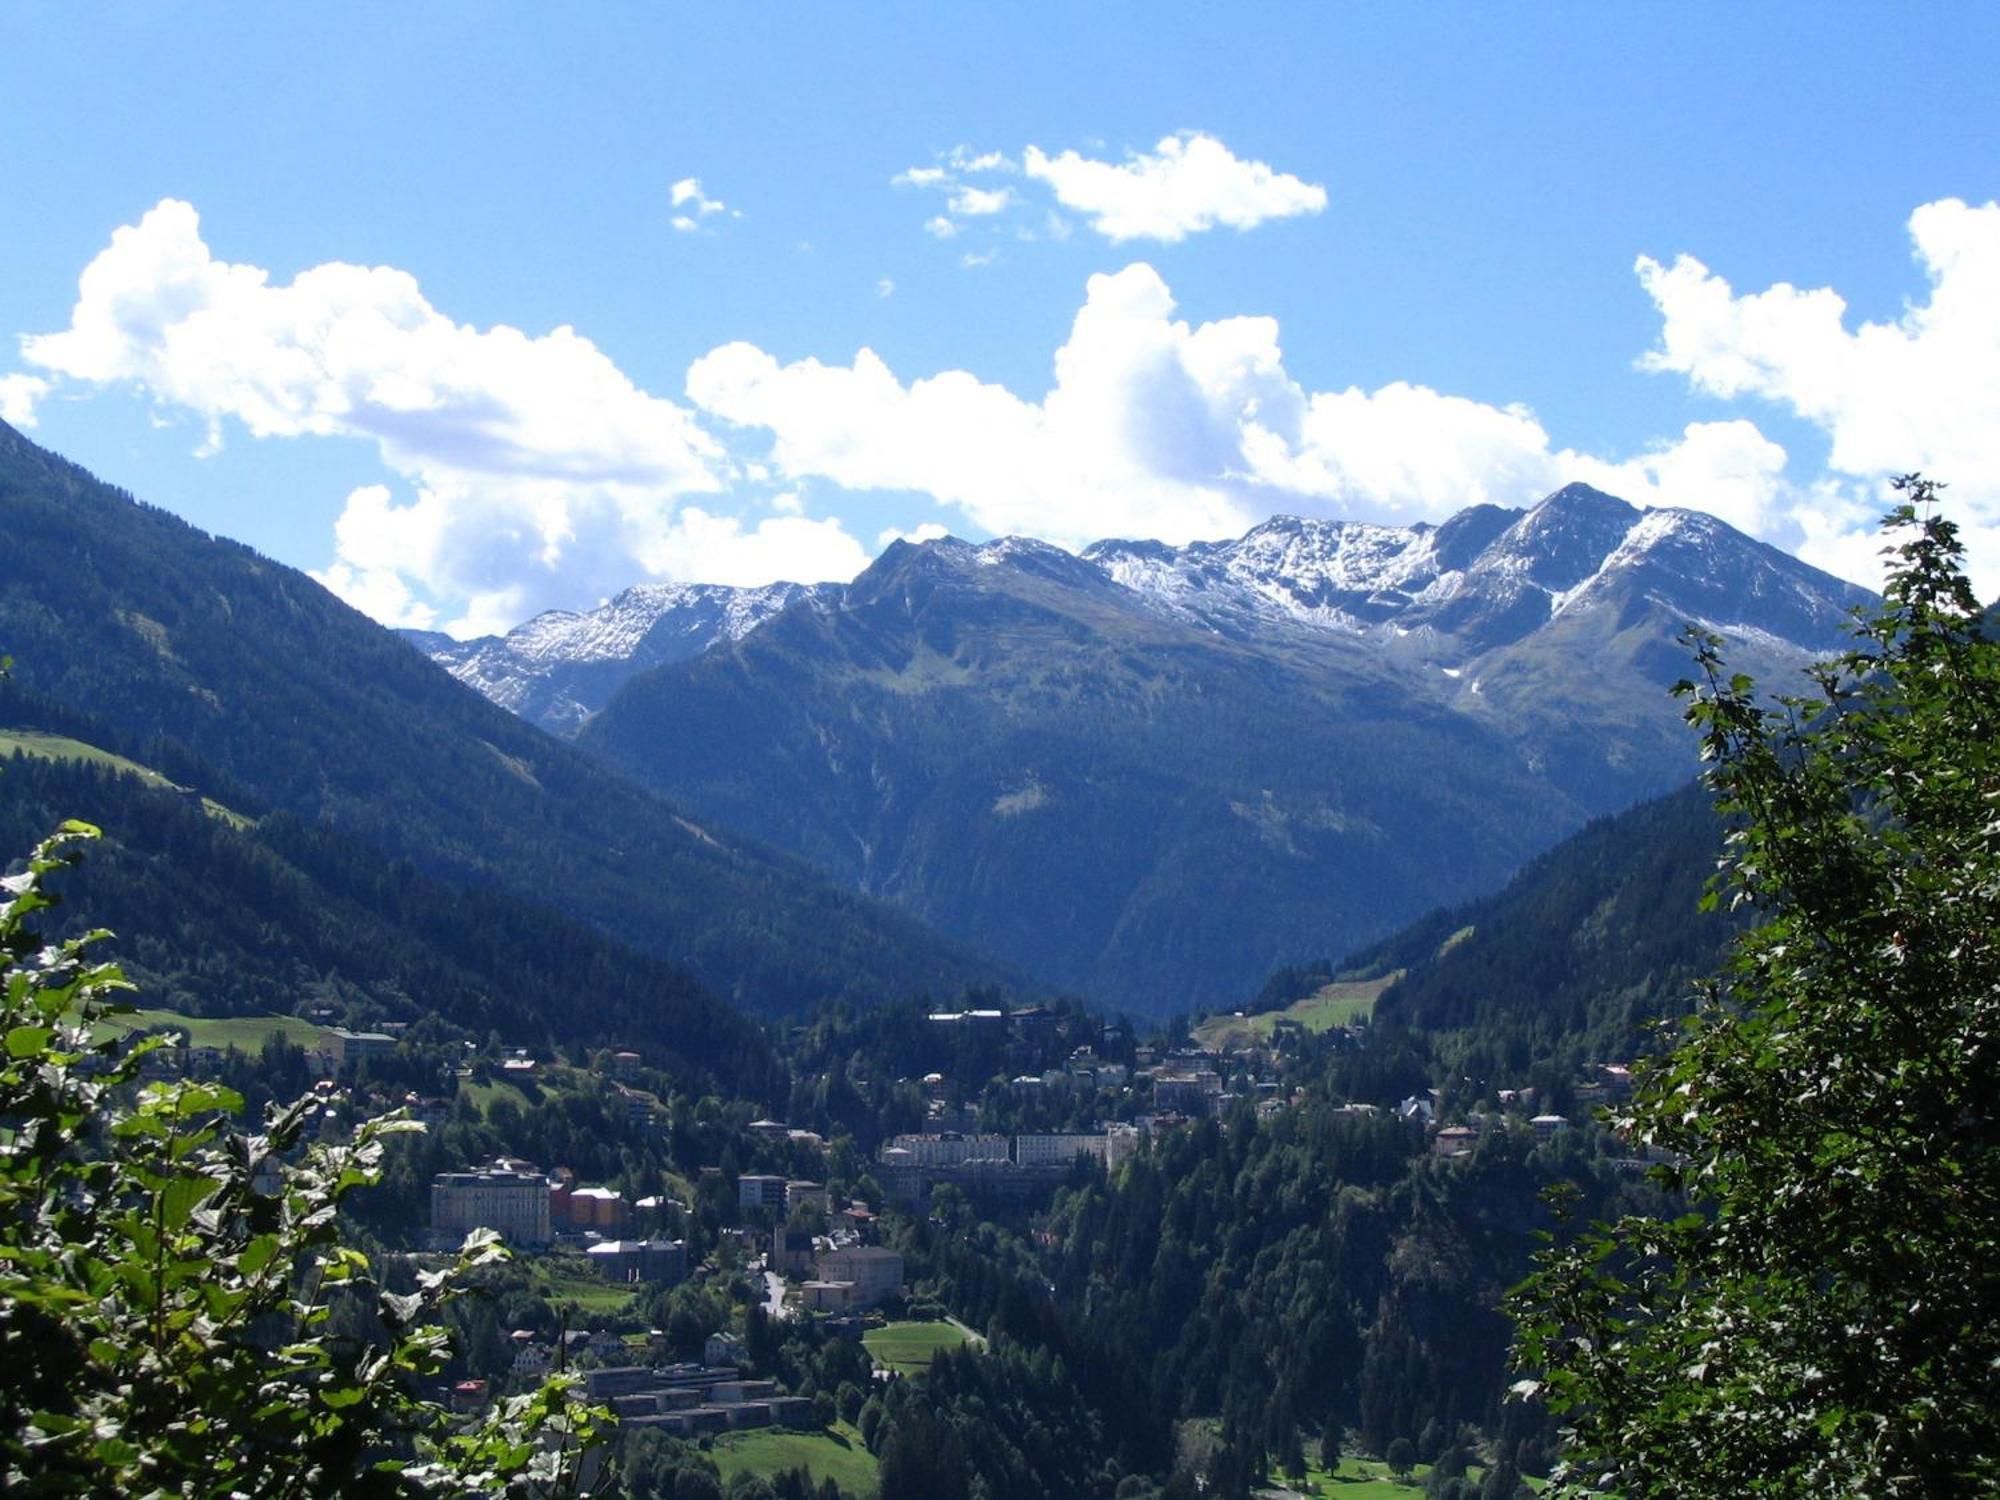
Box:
[402,584,828,736]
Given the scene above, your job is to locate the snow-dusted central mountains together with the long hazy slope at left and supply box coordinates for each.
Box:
[0,406,1868,1016]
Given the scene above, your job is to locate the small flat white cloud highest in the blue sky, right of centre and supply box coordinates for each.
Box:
[1022,130,1326,242]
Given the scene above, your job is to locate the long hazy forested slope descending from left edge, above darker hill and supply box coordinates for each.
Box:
[0,424,994,1010]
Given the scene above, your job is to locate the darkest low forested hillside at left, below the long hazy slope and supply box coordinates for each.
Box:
[0,712,774,1096]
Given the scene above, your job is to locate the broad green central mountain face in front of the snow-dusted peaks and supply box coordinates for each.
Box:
[580,542,1582,1014]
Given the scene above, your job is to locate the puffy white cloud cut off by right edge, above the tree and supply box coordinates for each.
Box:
[1636,198,2000,592]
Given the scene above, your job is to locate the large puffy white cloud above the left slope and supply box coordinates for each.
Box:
[22,200,858,630]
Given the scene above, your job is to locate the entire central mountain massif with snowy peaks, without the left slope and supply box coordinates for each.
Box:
[406,486,1870,1016]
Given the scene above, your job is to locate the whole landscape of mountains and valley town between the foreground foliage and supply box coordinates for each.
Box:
[0,414,1984,1500]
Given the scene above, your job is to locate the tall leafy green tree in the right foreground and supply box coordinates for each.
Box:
[1514,488,2000,1498]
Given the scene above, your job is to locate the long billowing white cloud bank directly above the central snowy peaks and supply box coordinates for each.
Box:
[688,264,1784,560]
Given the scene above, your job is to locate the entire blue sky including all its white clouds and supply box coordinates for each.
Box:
[0,4,2000,632]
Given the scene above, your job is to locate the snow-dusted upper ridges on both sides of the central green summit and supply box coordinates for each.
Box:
[414,484,1870,736]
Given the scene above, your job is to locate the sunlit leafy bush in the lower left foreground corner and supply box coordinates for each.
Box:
[0,822,600,1500]
